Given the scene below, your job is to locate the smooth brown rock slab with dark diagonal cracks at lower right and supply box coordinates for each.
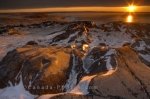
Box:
[89,46,150,99]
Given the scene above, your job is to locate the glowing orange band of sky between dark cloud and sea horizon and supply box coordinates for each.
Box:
[0,6,150,13]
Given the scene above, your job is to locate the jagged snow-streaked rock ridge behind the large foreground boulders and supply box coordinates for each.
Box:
[48,21,149,48]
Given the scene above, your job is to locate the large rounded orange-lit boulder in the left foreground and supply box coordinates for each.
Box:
[0,45,82,95]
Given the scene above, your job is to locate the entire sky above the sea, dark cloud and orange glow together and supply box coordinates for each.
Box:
[0,0,150,12]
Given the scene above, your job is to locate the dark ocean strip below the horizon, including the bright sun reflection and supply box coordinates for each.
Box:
[0,12,150,25]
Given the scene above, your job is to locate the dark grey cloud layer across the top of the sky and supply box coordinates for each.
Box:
[0,0,150,9]
